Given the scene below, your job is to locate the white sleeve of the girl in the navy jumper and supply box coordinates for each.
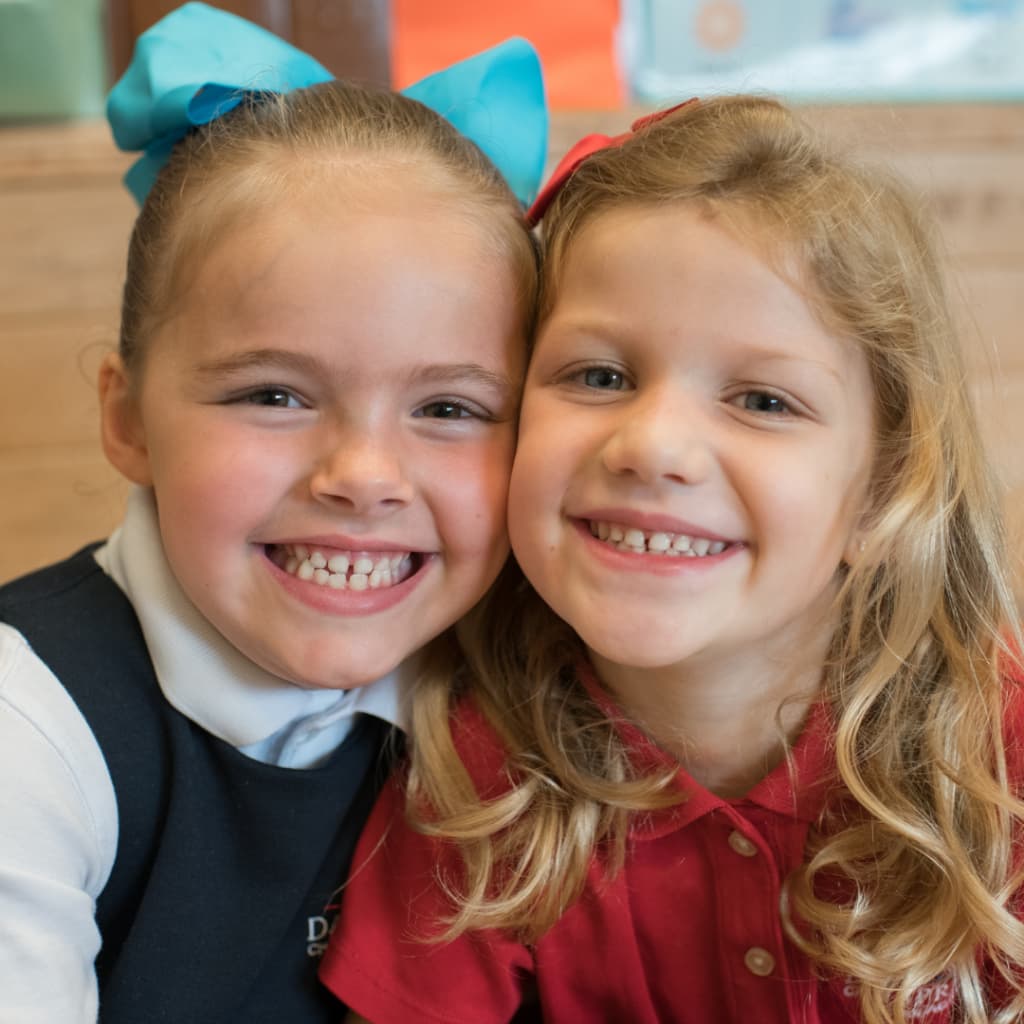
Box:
[0,624,118,1024]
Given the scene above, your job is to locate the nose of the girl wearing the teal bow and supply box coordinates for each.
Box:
[309,428,414,518]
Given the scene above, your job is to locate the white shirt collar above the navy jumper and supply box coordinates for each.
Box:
[96,487,412,746]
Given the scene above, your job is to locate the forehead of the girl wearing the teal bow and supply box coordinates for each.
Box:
[146,188,523,380]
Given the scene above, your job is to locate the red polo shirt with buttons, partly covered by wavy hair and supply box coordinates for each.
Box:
[321,659,1015,1024]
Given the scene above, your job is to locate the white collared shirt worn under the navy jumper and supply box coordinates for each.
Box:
[0,488,413,1024]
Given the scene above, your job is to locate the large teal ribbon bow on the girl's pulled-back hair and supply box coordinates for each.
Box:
[106,3,548,206]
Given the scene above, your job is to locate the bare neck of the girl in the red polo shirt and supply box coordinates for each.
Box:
[591,637,827,798]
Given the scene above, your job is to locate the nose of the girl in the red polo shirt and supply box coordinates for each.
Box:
[601,390,715,484]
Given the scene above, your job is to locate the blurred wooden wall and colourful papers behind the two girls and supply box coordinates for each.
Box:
[0,0,1024,597]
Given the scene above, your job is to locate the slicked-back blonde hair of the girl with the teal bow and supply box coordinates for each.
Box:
[119,81,537,371]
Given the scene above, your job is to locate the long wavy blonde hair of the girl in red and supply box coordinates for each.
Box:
[410,96,1024,1024]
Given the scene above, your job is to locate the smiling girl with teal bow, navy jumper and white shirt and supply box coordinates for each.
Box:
[0,3,546,1024]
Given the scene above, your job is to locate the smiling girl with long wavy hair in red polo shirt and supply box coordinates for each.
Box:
[322,96,1024,1024]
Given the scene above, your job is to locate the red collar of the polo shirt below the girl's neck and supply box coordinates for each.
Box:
[579,663,836,839]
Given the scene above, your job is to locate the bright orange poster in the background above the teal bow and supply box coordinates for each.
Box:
[391,0,626,110]
